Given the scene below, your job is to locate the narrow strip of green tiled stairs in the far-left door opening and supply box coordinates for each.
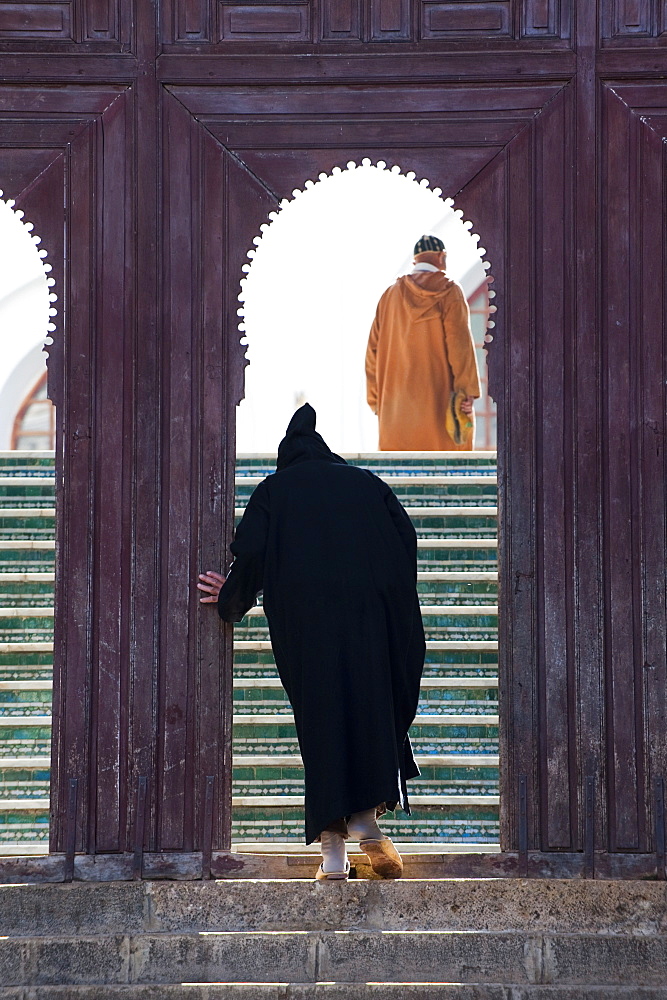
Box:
[0,451,55,854]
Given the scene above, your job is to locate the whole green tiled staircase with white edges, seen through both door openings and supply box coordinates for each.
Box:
[0,452,498,854]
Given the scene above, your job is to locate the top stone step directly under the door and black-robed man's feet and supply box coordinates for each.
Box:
[0,865,667,938]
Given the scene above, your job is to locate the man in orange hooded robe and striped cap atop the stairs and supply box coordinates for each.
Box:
[366,236,480,451]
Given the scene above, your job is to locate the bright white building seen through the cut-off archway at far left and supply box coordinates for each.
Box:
[0,192,55,451]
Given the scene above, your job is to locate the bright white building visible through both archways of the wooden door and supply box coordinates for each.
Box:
[0,161,496,452]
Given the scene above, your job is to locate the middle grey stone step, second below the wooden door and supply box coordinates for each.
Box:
[0,931,667,989]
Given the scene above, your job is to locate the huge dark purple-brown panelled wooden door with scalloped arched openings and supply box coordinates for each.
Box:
[0,0,667,874]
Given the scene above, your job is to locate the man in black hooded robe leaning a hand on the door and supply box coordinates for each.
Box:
[199,403,425,878]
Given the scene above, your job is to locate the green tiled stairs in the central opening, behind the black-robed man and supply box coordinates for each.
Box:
[233,452,498,850]
